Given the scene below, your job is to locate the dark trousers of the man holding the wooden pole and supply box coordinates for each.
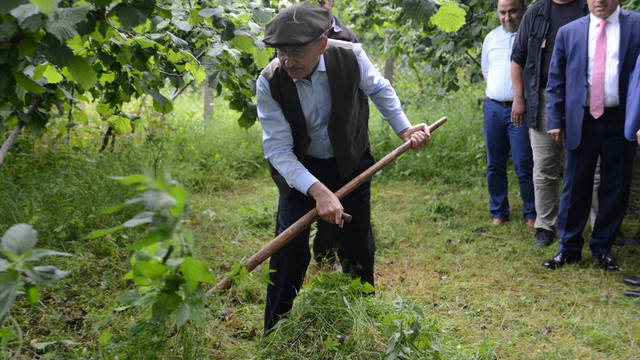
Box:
[264,151,375,333]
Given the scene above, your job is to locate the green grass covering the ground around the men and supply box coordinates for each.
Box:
[0,86,640,359]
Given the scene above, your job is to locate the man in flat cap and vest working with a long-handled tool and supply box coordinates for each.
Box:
[257,1,430,333]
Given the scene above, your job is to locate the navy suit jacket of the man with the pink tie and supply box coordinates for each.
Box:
[546,10,640,150]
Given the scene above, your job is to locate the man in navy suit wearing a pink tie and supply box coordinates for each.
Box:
[544,0,640,271]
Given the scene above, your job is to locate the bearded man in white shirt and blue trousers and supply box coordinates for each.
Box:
[482,0,536,228]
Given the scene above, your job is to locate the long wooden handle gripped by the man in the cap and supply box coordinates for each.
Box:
[208,117,447,294]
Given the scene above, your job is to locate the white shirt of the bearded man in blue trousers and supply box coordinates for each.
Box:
[482,26,516,101]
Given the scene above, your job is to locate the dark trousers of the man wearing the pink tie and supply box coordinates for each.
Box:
[558,107,637,256]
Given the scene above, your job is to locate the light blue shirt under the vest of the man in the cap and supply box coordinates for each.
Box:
[257,40,411,194]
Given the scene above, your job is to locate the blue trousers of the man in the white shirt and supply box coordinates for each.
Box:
[482,98,536,219]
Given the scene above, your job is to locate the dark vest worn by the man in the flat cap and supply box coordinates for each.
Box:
[261,39,369,197]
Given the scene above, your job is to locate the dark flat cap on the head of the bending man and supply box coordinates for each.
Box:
[263,1,331,48]
